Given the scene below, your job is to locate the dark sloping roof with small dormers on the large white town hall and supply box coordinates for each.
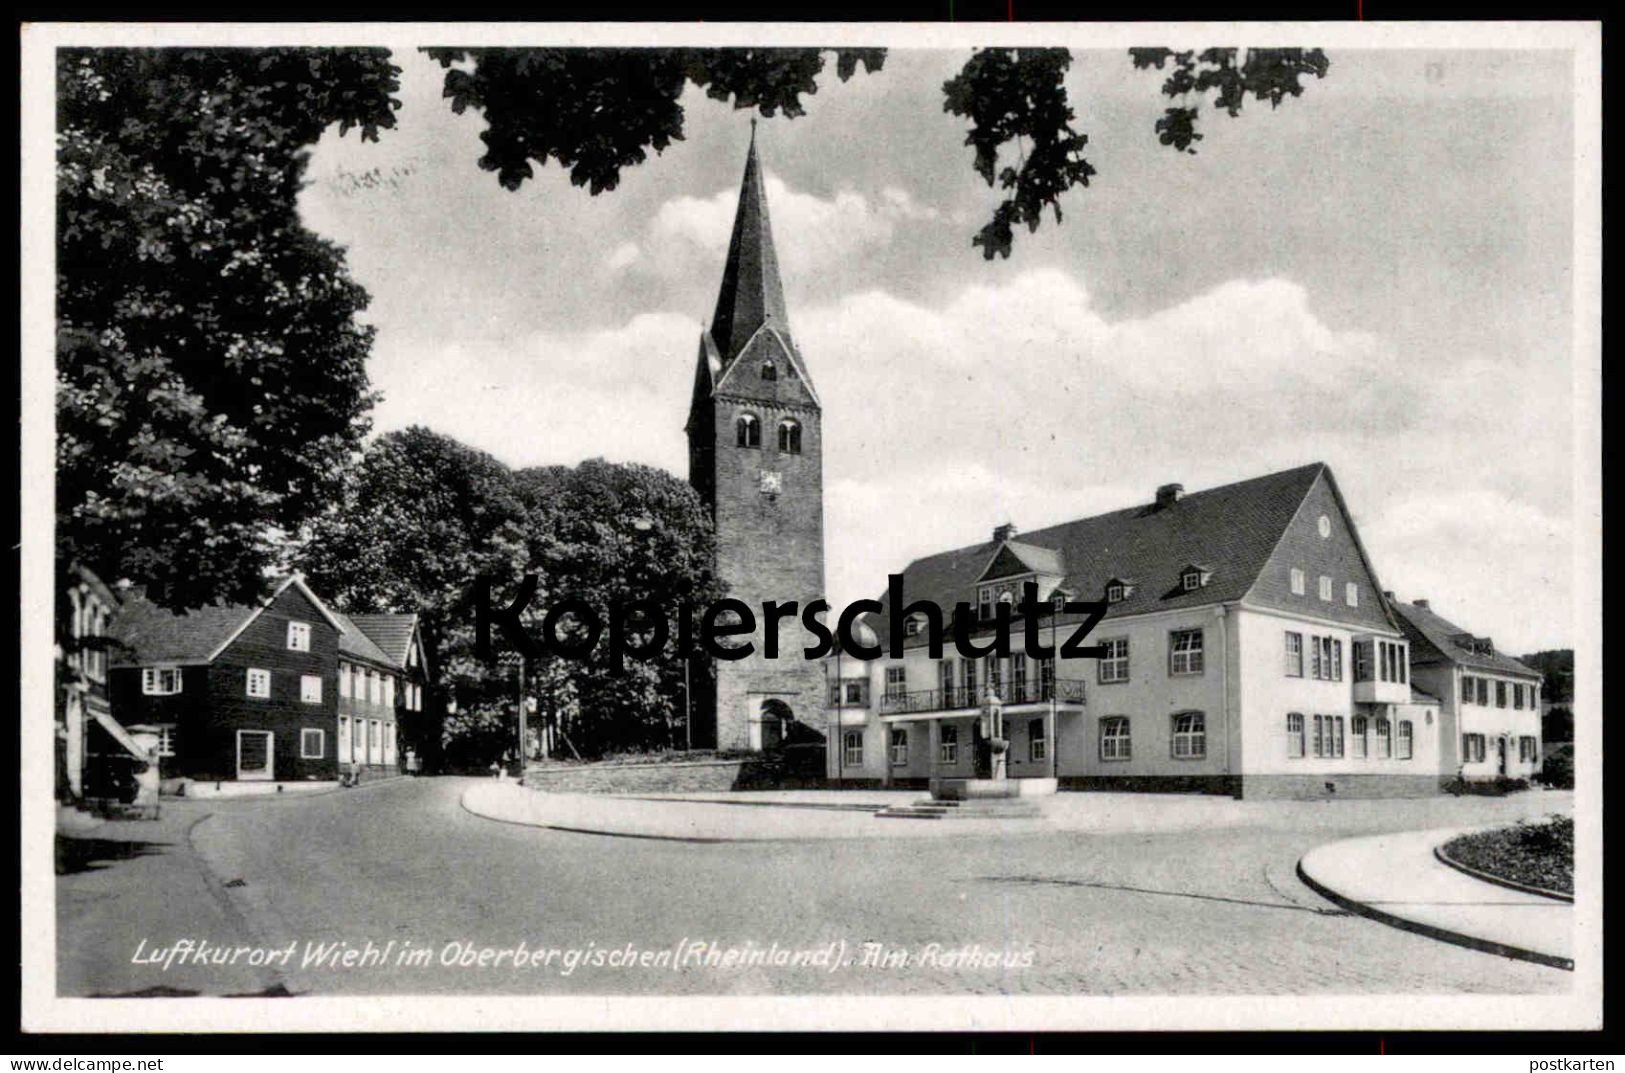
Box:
[873,462,1329,641]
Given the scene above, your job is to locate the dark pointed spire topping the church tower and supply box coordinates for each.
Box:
[712,127,790,364]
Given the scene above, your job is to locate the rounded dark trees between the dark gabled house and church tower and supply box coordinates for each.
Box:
[294,428,718,767]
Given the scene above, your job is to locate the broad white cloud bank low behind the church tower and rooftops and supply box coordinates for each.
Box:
[374,268,1571,647]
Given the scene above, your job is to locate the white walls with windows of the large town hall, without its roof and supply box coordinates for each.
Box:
[826,602,1441,790]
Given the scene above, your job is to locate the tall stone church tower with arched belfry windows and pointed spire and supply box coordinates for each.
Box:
[687,124,824,749]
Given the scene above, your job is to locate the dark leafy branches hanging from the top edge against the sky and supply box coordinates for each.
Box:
[424,47,1329,260]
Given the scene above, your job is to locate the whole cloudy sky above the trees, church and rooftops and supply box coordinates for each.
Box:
[301,49,1576,650]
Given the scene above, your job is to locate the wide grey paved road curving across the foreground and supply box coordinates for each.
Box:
[126,779,1573,995]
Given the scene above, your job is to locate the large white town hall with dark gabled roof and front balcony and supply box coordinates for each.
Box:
[826,463,1454,797]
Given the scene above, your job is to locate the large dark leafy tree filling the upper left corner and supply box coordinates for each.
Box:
[57,49,397,608]
